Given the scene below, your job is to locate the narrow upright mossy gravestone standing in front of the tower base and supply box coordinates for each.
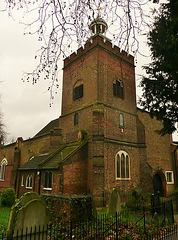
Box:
[108,188,121,214]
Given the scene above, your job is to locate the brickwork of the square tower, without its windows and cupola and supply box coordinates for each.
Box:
[60,34,140,202]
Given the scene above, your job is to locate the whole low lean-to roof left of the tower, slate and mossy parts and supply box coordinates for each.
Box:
[19,140,88,170]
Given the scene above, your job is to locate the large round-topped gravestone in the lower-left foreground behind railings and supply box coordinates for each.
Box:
[8,193,49,240]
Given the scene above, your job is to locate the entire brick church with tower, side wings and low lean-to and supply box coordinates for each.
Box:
[0,16,178,205]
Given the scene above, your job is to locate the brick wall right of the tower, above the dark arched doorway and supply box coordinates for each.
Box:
[138,110,174,194]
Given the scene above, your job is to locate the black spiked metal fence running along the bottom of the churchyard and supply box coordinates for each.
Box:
[0,195,178,240]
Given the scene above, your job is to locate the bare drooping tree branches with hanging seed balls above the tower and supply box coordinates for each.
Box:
[1,0,159,100]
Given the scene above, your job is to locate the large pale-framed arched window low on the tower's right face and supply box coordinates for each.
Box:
[115,151,130,179]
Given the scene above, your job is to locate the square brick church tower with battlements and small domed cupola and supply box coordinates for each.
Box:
[60,16,143,204]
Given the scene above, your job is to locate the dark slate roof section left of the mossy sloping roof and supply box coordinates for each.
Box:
[19,154,49,170]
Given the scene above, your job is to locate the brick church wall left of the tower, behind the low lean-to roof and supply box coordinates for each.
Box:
[0,132,61,191]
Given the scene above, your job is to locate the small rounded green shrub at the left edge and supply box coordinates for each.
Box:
[1,188,15,207]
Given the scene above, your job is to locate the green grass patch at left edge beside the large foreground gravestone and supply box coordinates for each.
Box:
[0,206,11,233]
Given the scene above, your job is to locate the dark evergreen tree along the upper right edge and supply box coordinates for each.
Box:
[140,0,178,135]
